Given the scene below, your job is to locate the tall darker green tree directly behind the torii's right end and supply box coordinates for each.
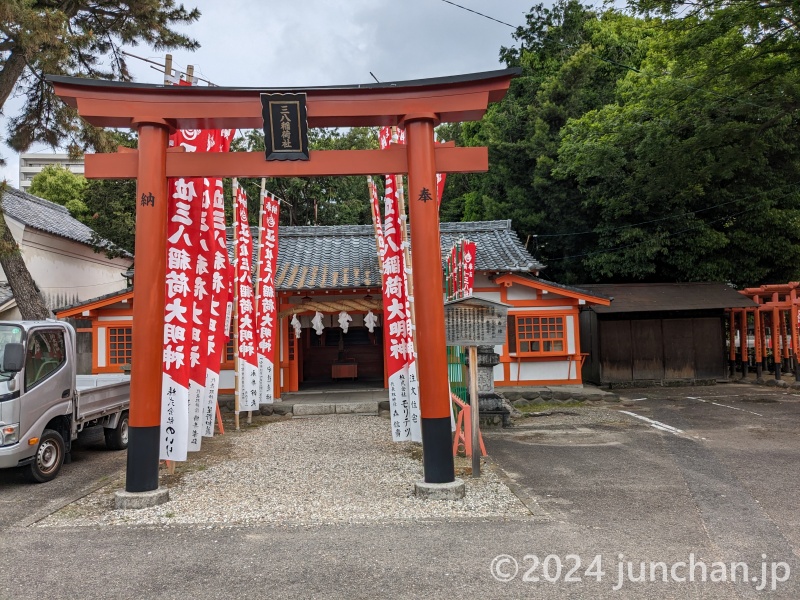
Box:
[440,0,646,283]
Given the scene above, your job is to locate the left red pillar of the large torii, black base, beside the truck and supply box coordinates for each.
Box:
[125,118,169,492]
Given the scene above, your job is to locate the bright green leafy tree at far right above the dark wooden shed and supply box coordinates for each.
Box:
[557,2,800,286]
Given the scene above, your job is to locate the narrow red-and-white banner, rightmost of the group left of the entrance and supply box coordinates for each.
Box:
[256,192,280,404]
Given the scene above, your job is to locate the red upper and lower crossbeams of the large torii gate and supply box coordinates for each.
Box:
[47,69,520,179]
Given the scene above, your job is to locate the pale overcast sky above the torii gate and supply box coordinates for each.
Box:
[0,0,550,186]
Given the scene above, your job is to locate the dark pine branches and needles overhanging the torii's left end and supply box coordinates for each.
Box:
[0,0,200,159]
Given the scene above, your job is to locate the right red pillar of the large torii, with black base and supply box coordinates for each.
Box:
[405,115,455,483]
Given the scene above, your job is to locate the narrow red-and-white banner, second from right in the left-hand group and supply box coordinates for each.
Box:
[233,179,258,412]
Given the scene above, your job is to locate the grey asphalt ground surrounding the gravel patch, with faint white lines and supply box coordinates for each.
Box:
[0,384,800,599]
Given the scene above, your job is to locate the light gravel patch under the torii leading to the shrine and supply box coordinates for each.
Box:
[38,415,531,527]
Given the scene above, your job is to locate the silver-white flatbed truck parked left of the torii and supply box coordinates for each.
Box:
[0,320,130,483]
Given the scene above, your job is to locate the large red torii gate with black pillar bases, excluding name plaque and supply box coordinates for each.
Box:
[47,69,520,492]
